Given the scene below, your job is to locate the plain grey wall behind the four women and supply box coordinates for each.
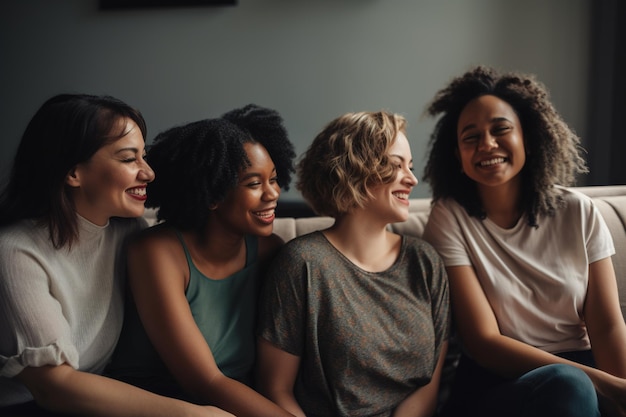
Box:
[0,0,591,200]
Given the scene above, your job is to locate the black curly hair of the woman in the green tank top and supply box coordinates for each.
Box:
[146,104,295,230]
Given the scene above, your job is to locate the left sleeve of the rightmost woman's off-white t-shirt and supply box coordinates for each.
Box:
[423,200,472,266]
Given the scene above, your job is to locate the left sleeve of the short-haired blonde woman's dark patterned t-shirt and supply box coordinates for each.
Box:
[258,242,307,356]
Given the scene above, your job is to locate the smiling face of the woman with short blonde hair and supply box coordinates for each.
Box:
[366,132,417,223]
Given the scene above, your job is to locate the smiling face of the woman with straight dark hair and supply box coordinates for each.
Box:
[66,119,154,225]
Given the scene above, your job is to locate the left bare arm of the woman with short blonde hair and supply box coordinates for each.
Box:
[252,338,305,417]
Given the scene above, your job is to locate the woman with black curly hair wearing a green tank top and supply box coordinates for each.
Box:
[105,105,295,417]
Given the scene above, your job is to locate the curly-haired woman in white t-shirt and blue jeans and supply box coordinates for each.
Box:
[424,67,626,417]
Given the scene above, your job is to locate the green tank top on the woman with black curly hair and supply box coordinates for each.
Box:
[107,231,259,390]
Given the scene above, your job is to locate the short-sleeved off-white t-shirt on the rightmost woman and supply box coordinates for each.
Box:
[424,189,615,353]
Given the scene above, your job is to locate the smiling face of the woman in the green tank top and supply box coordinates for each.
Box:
[214,143,280,236]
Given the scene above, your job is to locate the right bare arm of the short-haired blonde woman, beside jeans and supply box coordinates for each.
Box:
[393,342,448,417]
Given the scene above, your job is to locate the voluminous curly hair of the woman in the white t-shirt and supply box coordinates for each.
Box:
[423,66,588,227]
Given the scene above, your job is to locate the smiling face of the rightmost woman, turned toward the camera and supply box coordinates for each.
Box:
[457,95,526,192]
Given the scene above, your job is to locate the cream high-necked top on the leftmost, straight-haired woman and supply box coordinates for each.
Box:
[0,217,141,407]
